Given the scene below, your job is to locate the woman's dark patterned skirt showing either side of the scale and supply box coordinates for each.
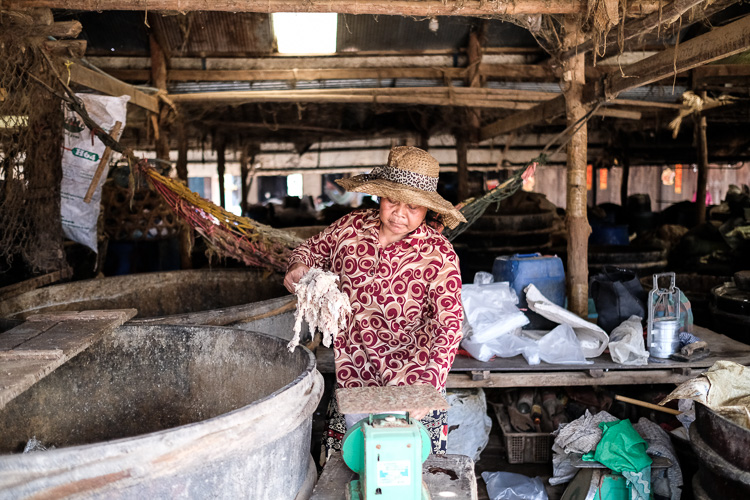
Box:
[320,389,448,466]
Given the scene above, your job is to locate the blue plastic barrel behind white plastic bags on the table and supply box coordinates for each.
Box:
[492,253,565,309]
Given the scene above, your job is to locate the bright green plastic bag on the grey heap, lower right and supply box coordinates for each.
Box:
[582,420,652,472]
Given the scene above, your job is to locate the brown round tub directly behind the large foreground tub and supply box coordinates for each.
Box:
[0,269,288,325]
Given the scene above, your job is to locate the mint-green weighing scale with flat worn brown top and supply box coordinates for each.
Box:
[336,385,450,500]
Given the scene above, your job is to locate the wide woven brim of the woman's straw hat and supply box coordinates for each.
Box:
[336,175,466,229]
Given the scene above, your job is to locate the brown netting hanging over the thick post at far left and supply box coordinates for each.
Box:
[0,16,66,275]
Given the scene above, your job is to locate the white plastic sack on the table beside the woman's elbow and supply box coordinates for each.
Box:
[461,281,529,343]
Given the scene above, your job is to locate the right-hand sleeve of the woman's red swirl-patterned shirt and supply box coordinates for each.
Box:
[419,243,463,390]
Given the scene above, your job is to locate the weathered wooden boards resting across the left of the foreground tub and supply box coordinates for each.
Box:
[0,309,137,408]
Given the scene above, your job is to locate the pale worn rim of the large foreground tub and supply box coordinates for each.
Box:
[0,325,324,498]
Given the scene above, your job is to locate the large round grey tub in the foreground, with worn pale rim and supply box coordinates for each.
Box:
[0,325,323,500]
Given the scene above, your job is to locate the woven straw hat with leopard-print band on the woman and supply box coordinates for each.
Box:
[336,146,466,229]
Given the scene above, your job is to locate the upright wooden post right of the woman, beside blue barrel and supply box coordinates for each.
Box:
[562,17,591,317]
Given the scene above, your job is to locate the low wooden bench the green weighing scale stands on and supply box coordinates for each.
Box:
[310,453,477,500]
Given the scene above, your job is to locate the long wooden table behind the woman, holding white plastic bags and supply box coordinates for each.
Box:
[316,326,750,388]
